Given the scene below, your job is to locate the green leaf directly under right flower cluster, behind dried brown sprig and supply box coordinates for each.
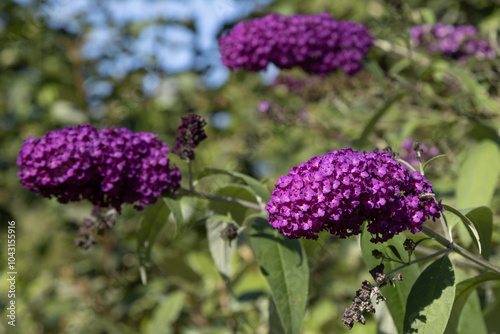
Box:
[361,226,420,333]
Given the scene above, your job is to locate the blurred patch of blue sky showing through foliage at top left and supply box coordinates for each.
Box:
[13,0,273,98]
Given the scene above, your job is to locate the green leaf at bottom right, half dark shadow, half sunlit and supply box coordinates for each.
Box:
[403,256,455,334]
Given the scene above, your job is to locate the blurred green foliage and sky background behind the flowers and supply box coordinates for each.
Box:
[0,0,500,334]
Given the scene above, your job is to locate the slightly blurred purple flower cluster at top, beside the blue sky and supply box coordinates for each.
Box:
[219,13,373,76]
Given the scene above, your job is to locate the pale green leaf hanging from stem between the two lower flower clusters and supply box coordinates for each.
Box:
[205,215,237,283]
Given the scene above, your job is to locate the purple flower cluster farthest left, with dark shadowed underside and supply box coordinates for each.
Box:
[17,125,181,211]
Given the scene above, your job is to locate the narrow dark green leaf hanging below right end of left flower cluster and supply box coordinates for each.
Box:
[137,200,170,284]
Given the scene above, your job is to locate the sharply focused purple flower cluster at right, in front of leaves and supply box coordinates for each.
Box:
[266,148,444,243]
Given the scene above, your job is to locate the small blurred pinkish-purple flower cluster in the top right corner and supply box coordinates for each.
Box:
[410,22,496,62]
